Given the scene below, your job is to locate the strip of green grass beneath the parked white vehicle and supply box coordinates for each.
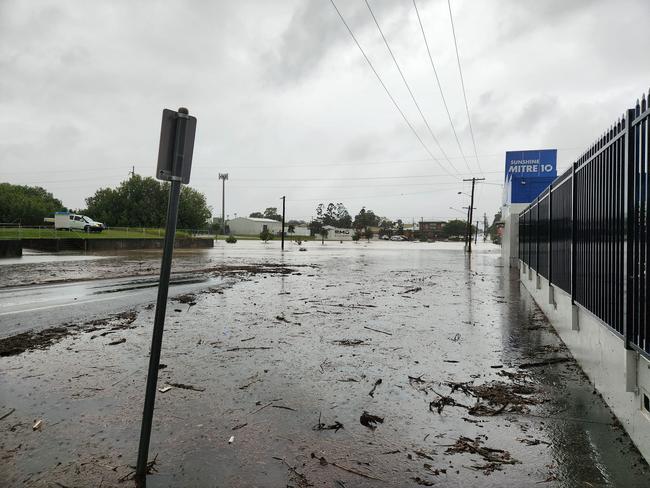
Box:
[0,227,197,239]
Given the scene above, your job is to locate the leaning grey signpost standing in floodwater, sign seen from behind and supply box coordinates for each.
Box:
[135,108,196,487]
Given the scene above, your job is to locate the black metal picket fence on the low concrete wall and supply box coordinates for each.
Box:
[519,90,650,356]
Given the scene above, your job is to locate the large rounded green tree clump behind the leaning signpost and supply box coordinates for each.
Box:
[84,175,211,229]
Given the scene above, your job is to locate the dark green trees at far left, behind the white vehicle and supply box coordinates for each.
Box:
[0,183,66,225]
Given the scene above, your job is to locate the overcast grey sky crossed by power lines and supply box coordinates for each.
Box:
[0,0,650,222]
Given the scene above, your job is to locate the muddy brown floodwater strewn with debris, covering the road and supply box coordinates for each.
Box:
[0,241,650,488]
